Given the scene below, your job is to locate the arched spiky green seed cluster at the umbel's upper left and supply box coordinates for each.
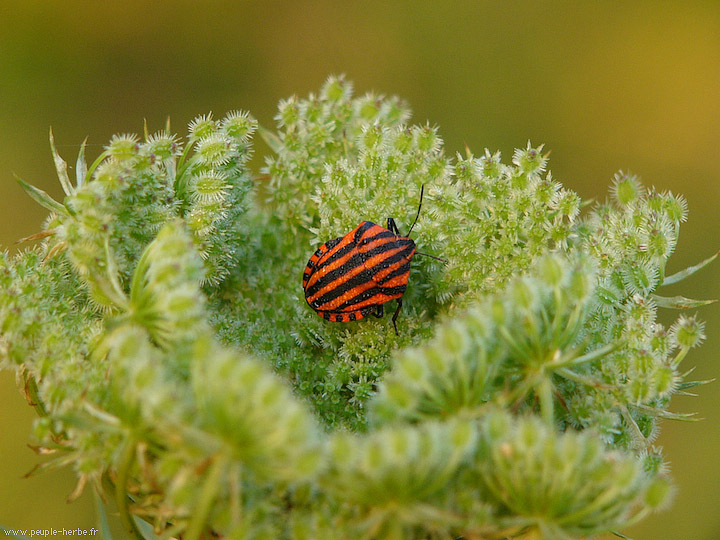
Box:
[57,109,256,307]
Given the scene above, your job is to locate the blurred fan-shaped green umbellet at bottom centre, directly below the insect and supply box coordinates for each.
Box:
[321,420,477,539]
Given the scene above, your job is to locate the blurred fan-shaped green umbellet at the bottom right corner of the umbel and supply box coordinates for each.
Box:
[478,412,667,540]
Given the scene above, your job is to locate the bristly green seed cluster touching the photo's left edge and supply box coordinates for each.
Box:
[0,250,105,414]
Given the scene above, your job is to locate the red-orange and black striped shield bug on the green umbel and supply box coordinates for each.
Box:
[303,186,447,335]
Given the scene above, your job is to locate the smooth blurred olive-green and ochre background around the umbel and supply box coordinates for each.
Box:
[0,0,720,540]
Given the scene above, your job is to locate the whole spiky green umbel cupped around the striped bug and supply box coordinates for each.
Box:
[0,77,712,540]
